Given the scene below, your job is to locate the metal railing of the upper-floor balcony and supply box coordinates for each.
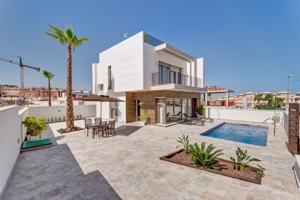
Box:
[152,72,202,87]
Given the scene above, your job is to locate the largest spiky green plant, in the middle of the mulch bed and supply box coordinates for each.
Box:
[189,142,223,170]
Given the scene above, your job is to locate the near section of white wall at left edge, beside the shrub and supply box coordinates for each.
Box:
[0,106,21,196]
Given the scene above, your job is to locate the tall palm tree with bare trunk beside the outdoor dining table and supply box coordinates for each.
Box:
[46,25,88,132]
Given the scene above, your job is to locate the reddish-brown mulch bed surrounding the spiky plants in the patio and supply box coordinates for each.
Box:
[160,149,262,184]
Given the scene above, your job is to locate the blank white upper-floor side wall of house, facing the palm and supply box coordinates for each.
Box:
[97,32,144,94]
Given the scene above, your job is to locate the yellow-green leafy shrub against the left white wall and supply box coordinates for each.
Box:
[23,116,47,136]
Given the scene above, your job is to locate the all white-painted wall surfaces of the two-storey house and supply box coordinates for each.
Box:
[92,32,204,121]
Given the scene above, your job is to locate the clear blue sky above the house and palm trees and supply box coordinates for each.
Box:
[0,0,300,92]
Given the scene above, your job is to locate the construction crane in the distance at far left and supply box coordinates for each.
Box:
[0,54,41,100]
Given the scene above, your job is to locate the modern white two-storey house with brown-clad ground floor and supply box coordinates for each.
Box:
[92,32,206,124]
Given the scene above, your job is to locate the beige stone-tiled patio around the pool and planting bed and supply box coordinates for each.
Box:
[5,121,300,200]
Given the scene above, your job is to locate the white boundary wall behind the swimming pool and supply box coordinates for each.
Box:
[205,107,288,125]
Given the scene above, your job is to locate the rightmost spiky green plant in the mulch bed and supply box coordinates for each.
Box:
[230,147,260,172]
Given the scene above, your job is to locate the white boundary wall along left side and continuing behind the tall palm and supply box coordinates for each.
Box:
[0,105,96,195]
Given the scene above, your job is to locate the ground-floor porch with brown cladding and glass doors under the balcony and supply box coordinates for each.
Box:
[126,90,205,125]
